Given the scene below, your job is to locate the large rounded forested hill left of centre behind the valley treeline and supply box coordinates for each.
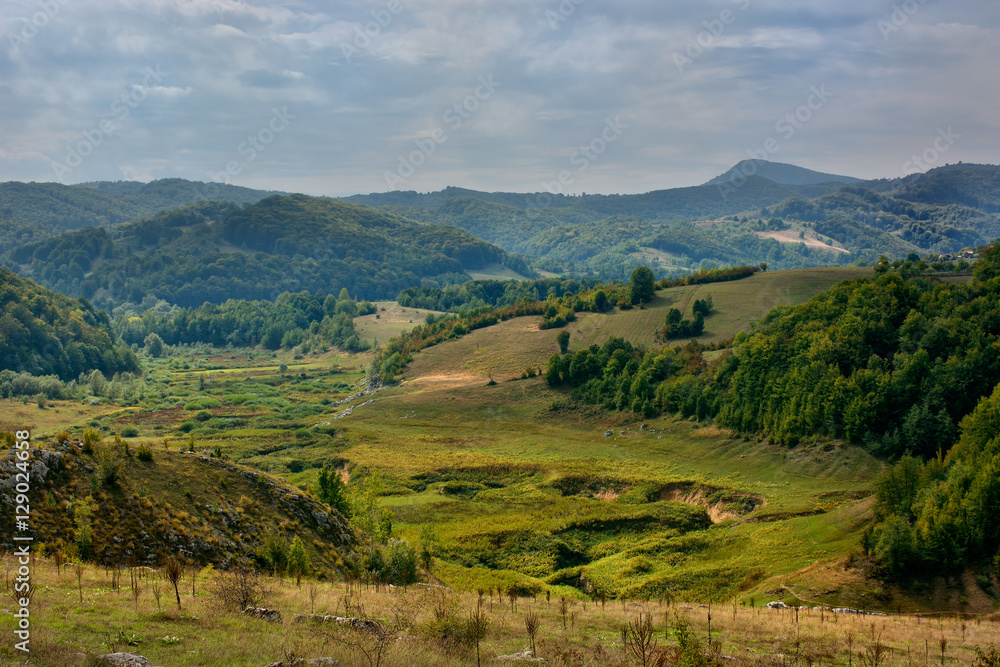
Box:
[5,195,527,307]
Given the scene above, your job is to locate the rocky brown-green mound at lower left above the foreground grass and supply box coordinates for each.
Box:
[0,436,355,571]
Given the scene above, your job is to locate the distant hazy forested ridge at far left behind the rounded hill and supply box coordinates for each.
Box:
[0,178,278,243]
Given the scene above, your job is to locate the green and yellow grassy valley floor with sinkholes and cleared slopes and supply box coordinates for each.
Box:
[0,269,994,636]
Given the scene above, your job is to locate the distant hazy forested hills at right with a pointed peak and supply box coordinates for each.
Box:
[348,161,1000,280]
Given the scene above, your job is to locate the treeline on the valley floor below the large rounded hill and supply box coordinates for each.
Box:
[115,288,375,356]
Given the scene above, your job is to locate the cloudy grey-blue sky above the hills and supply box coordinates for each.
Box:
[0,0,1000,196]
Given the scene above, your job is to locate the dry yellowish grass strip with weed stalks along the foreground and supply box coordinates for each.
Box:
[0,556,1000,667]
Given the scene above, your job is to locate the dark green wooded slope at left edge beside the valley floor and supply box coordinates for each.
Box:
[0,269,139,380]
